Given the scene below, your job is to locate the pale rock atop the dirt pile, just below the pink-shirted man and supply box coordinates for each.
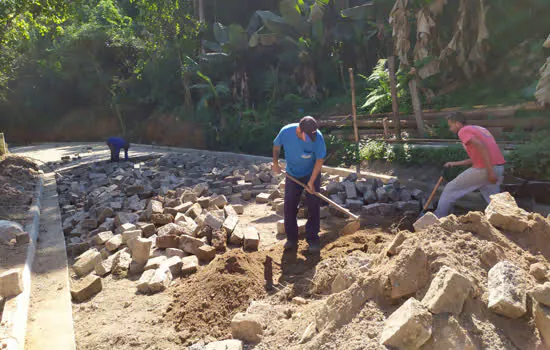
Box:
[485,192,529,233]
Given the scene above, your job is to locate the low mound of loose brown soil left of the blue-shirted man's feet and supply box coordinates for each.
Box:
[168,250,272,344]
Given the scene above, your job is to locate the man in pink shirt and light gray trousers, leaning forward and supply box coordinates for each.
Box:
[435,112,506,218]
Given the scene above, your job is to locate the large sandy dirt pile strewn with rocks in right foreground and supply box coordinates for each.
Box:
[243,205,550,349]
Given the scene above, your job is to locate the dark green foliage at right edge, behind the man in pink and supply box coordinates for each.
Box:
[509,132,550,180]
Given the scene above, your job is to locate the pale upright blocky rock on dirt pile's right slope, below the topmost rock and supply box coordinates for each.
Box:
[488,260,527,318]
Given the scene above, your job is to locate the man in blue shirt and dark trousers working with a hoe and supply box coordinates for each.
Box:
[273,117,327,253]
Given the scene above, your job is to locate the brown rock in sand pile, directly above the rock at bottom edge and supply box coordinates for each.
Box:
[387,239,430,299]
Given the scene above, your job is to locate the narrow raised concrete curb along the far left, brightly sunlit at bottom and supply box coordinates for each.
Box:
[2,174,44,350]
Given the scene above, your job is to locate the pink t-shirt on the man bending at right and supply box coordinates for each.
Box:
[458,125,506,168]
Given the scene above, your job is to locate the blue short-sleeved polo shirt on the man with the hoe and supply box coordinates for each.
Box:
[273,123,327,177]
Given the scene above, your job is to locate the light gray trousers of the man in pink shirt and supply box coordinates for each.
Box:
[434,165,504,218]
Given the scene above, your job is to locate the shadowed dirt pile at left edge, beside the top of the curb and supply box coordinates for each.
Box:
[0,156,38,221]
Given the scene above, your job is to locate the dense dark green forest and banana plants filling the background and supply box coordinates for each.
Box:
[0,0,550,173]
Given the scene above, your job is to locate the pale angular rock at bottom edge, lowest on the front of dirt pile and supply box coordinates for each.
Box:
[380,298,432,350]
